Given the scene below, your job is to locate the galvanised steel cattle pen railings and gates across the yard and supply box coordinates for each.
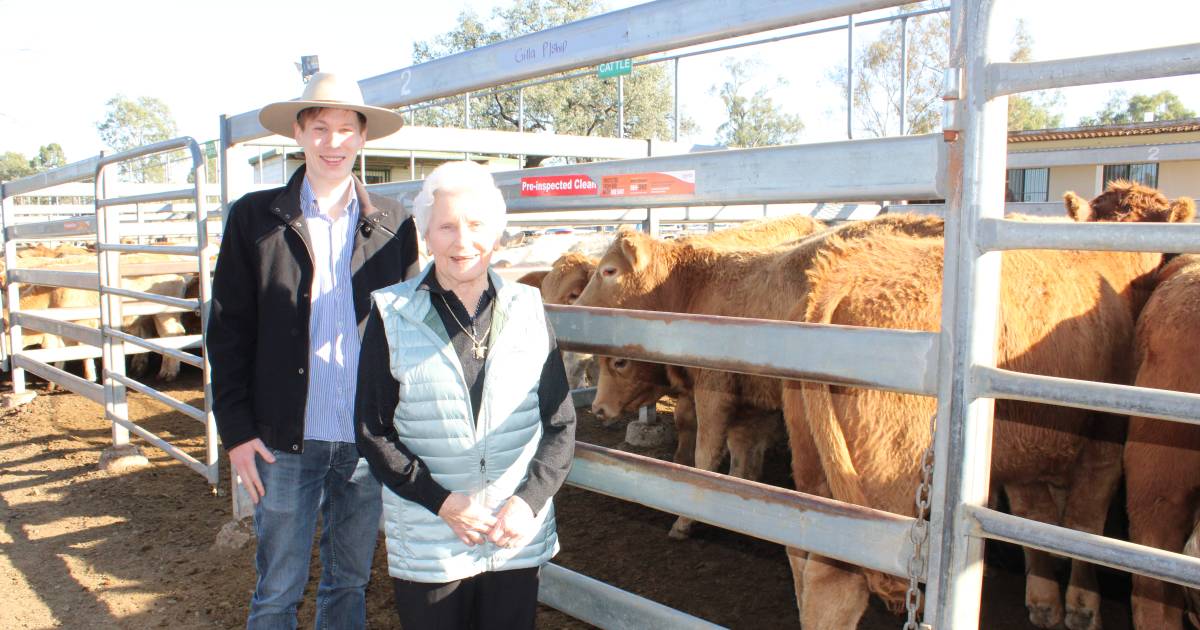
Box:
[0,0,1200,629]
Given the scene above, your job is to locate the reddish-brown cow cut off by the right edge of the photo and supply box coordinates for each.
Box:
[1124,256,1200,630]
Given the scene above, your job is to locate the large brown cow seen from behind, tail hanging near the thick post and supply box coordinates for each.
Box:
[784,182,1194,630]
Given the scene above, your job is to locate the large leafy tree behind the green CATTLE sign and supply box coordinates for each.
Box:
[413,0,695,166]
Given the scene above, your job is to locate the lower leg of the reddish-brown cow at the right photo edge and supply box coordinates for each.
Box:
[1124,432,1194,630]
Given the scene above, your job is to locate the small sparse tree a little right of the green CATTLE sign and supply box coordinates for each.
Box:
[709,58,804,148]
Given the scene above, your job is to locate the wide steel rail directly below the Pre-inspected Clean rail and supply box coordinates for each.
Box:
[546,305,937,396]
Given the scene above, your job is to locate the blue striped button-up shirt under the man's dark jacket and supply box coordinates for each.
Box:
[300,178,361,443]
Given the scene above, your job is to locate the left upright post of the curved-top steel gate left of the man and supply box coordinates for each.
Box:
[96,166,130,448]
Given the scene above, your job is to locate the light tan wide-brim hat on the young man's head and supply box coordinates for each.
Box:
[258,72,404,140]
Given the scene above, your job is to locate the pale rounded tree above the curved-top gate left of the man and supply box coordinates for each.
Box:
[96,95,176,182]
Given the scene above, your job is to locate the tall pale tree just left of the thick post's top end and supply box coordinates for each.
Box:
[829,0,950,136]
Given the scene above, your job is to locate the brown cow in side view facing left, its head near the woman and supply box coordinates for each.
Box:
[576,215,942,538]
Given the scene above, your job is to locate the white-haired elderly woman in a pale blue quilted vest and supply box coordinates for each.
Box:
[355,162,575,630]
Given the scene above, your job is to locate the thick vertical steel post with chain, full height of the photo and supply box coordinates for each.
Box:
[925,0,1008,629]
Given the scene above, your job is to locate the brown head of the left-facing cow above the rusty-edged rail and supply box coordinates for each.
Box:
[575,229,673,311]
